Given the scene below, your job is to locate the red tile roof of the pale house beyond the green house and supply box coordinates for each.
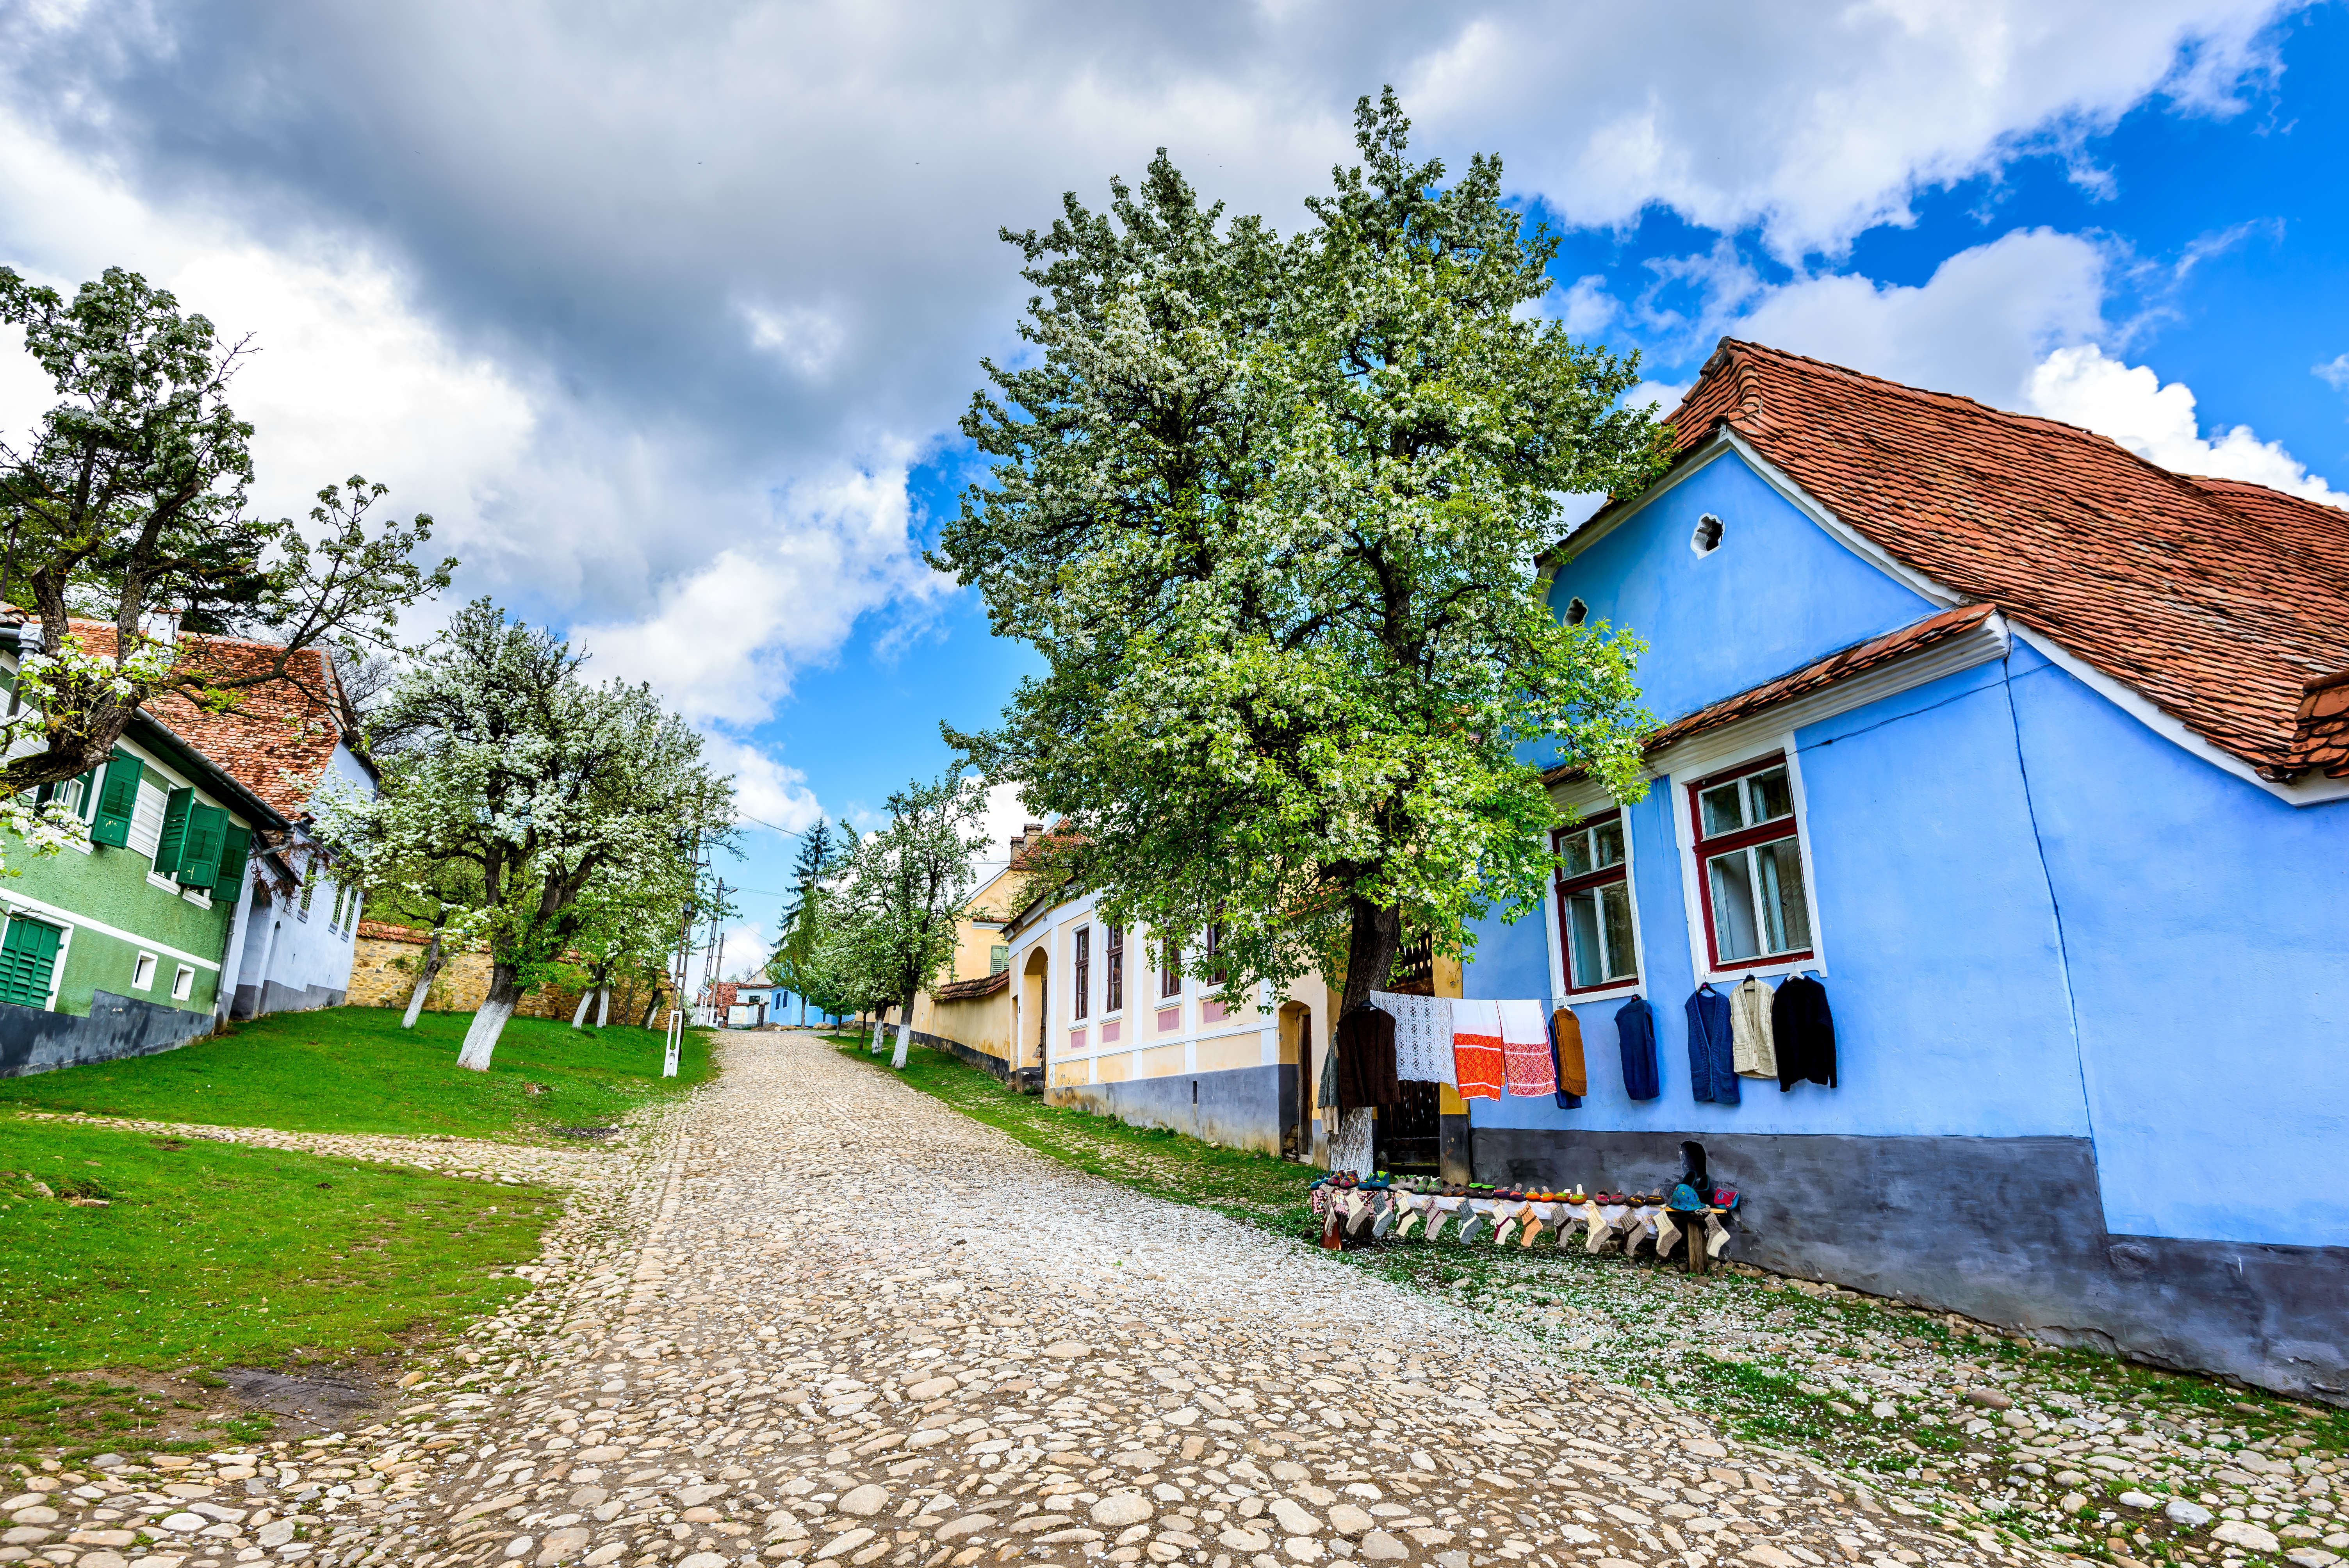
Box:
[59,620,343,817]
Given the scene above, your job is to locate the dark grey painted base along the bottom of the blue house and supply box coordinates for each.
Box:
[1473,1127,2349,1404]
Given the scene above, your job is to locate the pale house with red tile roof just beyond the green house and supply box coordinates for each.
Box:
[73,620,376,1019]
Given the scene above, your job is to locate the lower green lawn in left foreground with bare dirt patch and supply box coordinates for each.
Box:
[0,1112,561,1453]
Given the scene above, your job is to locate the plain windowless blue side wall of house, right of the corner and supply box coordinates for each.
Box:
[2013,652,2349,1246]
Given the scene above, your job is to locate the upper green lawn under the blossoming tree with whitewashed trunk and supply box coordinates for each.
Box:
[0,1007,712,1139]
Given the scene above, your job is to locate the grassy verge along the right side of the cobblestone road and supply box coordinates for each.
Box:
[834,1035,2349,1561]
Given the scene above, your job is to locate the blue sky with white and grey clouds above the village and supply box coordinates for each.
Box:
[0,0,2349,967]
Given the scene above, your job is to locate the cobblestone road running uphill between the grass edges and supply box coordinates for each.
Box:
[0,1035,2060,1568]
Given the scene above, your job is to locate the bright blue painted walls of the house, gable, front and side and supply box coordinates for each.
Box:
[1463,455,2349,1246]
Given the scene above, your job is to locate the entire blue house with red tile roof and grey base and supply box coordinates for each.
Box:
[1463,340,2349,1399]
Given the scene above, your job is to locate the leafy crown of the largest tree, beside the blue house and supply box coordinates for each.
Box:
[932,94,1663,995]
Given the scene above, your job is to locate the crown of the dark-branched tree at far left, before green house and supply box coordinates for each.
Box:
[0,267,456,793]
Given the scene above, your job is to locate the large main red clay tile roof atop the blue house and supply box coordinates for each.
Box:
[1672,338,2349,779]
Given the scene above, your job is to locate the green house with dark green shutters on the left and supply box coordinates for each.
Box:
[0,714,289,1077]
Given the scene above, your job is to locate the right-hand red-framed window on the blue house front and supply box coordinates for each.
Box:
[1689,754,1811,972]
